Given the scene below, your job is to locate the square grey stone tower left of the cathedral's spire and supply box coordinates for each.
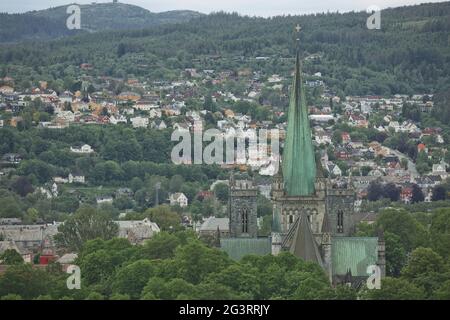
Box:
[228,176,258,238]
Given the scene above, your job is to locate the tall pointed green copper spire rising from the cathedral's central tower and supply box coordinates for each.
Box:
[283,52,316,196]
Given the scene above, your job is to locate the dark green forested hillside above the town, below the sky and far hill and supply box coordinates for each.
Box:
[0,2,450,95]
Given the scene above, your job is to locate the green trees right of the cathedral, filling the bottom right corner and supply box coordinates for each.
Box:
[358,208,450,299]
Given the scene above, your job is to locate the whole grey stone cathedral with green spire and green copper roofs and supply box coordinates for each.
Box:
[220,27,385,287]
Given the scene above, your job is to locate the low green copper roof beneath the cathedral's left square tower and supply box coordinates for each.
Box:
[220,238,272,260]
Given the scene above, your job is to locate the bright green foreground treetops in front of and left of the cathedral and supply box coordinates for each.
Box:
[0,231,356,300]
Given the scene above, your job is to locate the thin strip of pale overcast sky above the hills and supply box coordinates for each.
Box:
[0,0,443,17]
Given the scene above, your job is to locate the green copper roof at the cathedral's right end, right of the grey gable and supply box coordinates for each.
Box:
[331,237,378,277]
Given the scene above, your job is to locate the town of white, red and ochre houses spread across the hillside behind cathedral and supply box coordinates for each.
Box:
[0,61,448,262]
